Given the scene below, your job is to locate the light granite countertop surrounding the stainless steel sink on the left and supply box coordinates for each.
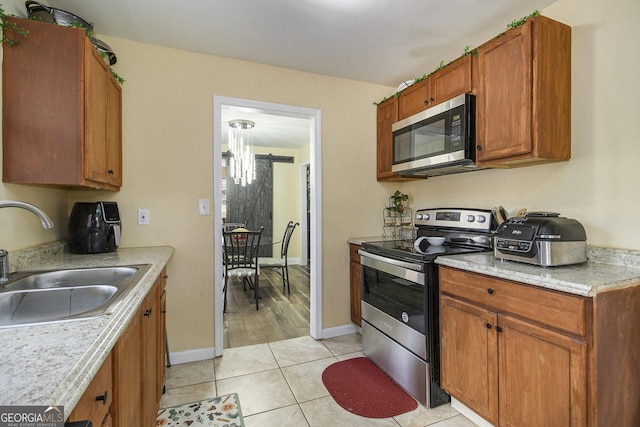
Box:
[0,246,174,416]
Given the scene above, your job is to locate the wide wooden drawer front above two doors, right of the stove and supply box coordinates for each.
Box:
[440,266,587,336]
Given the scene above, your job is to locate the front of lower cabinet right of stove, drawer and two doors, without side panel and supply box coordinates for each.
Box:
[440,268,588,427]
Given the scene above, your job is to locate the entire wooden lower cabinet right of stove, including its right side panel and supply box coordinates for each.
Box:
[440,266,640,427]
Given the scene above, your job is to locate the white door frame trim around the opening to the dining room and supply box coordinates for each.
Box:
[213,96,322,357]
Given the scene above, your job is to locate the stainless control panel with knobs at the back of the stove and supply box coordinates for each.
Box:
[415,208,493,232]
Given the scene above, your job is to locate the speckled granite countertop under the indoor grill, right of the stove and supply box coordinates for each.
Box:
[436,247,640,297]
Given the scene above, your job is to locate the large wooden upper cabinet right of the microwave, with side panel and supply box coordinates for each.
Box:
[476,16,571,167]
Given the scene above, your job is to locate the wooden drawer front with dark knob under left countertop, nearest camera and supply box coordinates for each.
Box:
[68,355,113,427]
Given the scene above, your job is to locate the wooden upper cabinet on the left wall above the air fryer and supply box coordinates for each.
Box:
[2,18,122,190]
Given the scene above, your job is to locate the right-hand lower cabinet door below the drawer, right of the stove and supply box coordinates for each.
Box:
[498,315,587,427]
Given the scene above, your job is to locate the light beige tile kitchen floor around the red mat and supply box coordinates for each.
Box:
[160,334,475,427]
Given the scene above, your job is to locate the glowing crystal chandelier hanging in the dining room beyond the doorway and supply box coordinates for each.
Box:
[229,120,256,187]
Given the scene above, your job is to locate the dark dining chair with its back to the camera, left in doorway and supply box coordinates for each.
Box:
[222,227,264,312]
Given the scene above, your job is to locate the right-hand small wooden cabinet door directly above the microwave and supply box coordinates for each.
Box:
[429,55,473,107]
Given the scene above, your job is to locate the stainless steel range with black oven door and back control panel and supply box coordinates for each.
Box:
[359,208,497,407]
